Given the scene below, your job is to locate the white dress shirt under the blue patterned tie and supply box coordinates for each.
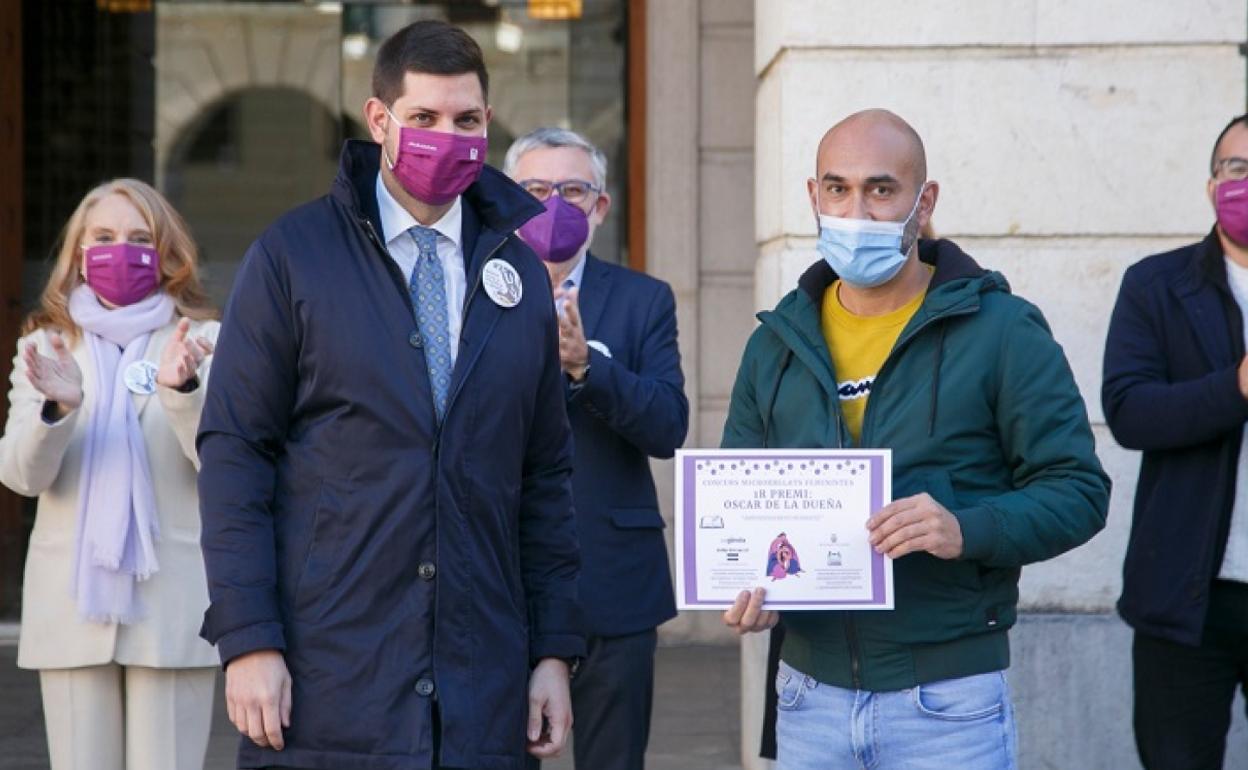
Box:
[377,171,468,367]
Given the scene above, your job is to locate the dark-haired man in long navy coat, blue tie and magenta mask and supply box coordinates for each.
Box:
[198,21,585,770]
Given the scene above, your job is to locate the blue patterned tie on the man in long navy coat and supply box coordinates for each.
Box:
[408,225,451,422]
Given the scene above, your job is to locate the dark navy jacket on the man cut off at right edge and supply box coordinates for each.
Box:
[1101,233,1248,645]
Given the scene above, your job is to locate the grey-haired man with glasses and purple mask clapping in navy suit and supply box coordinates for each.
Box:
[503,129,689,770]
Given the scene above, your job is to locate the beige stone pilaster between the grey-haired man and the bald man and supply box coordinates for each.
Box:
[646,0,755,644]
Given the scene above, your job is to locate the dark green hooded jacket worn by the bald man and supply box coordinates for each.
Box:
[723,240,1109,691]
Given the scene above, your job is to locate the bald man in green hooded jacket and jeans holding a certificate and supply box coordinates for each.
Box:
[716,110,1109,770]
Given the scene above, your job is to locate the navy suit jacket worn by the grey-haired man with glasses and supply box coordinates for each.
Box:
[568,255,689,636]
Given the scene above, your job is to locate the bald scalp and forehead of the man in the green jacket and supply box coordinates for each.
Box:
[815,110,927,192]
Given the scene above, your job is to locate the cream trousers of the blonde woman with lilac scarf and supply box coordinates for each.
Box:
[39,664,217,770]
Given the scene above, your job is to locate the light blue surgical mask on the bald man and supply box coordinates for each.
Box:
[819,185,926,288]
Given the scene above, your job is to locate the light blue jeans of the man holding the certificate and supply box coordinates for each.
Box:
[776,660,1017,770]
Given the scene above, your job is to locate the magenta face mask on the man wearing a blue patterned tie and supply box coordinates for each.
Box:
[382,110,488,206]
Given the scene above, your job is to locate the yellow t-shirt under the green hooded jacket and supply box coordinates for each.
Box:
[822,281,927,443]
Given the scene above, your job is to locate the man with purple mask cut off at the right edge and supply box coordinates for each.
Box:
[1101,115,1248,770]
